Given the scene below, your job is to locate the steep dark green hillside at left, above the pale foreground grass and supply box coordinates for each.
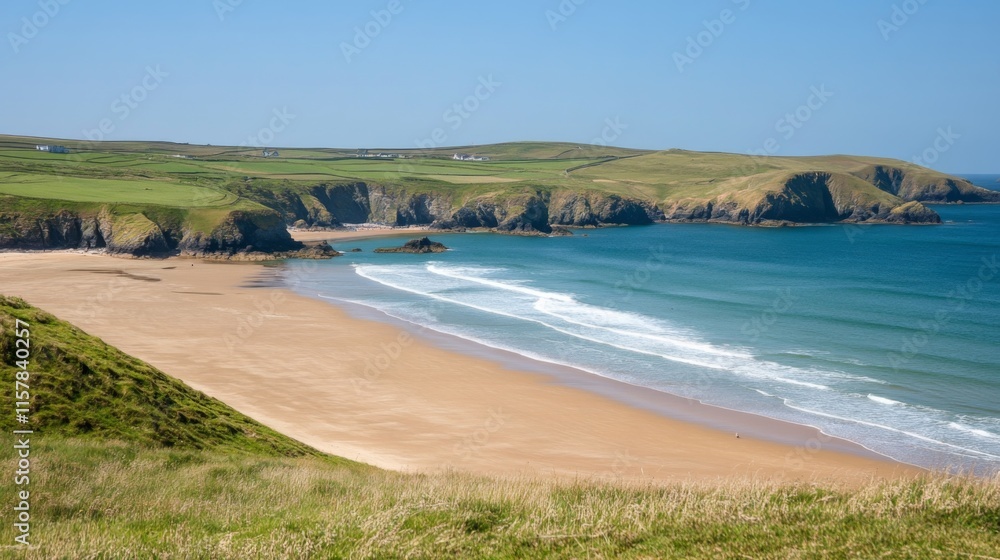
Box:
[0,295,320,457]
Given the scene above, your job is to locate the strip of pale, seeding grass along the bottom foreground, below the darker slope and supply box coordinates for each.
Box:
[0,437,1000,559]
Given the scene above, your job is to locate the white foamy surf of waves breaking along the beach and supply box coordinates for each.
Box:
[342,263,1000,468]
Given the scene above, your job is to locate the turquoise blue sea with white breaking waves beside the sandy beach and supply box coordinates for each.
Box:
[290,176,1000,473]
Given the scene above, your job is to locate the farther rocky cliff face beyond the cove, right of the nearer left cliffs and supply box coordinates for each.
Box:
[268,172,960,234]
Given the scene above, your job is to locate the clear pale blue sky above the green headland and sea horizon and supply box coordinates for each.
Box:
[0,0,1000,173]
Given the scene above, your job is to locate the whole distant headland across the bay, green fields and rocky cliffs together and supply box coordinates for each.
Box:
[0,136,1000,254]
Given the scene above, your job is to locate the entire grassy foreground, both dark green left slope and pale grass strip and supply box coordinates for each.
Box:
[0,296,1000,559]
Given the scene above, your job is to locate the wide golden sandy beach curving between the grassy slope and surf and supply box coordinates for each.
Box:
[0,247,919,483]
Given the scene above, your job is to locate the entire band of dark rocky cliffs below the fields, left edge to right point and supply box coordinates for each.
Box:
[0,166,984,256]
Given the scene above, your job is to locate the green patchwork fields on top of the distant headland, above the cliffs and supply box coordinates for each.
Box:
[0,137,968,205]
